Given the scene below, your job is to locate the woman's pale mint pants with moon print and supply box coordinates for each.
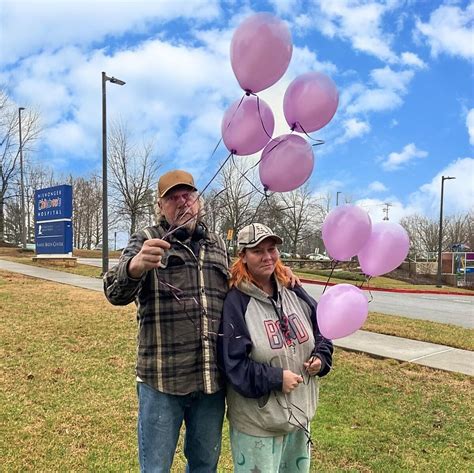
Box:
[229,426,311,473]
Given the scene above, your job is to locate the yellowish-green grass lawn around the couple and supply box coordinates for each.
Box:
[0,272,474,472]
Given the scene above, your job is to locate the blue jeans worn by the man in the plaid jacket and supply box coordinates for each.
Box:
[137,383,225,473]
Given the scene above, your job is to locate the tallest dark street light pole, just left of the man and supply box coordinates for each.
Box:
[102,72,125,274]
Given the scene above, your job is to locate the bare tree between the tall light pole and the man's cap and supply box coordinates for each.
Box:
[108,123,159,233]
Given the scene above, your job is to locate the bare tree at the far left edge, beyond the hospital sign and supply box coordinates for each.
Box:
[0,89,41,240]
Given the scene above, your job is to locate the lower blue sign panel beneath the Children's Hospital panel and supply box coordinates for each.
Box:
[35,220,72,254]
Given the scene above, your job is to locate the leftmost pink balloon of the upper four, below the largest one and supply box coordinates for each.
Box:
[221,95,275,156]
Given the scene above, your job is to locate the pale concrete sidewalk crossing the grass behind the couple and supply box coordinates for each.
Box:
[0,259,474,376]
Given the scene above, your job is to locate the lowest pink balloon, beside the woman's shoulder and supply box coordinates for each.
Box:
[316,284,369,339]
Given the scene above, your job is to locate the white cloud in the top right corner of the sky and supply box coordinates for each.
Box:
[415,2,474,60]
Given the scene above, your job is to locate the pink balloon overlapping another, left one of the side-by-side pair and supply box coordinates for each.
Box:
[322,205,372,261]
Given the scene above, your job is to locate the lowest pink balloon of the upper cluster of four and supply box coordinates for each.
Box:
[259,135,314,192]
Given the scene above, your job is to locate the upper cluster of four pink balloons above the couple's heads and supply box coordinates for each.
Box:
[221,13,339,192]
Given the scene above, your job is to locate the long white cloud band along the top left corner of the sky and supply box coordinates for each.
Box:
[1,0,220,64]
